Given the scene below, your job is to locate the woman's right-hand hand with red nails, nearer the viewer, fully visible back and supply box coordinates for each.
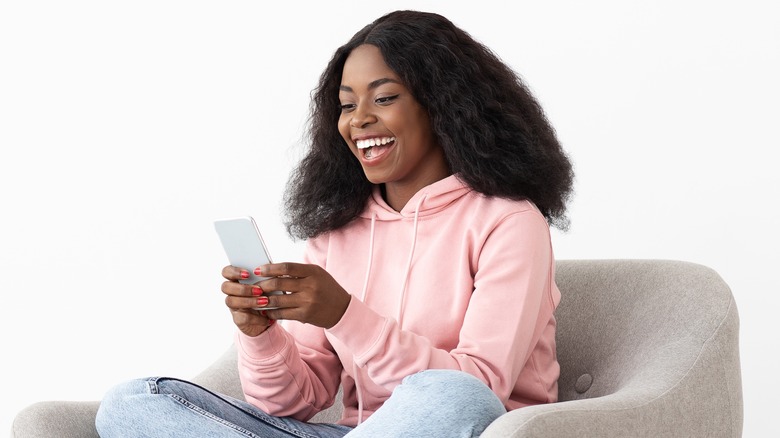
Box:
[255,263,351,329]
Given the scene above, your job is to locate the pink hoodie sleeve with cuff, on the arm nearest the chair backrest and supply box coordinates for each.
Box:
[329,210,560,403]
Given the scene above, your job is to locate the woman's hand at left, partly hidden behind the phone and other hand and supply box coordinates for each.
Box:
[222,266,276,337]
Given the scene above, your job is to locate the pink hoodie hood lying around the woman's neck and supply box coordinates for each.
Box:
[360,175,472,221]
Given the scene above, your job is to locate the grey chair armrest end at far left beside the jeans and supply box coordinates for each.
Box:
[11,401,100,438]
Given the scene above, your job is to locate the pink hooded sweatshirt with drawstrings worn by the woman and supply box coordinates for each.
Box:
[236,176,560,426]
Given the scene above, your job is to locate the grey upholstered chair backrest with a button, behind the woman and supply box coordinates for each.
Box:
[556,260,742,430]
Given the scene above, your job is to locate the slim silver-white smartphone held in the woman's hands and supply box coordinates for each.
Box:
[214,216,284,304]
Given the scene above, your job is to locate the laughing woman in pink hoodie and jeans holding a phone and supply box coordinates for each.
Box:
[97,11,572,437]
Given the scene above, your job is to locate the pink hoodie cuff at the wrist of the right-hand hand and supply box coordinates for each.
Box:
[327,296,393,367]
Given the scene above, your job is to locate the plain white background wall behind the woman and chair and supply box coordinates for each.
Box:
[0,0,780,437]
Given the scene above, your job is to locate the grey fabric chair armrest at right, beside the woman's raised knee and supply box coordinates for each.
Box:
[481,294,743,438]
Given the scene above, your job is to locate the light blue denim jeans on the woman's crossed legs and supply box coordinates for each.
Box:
[95,370,506,438]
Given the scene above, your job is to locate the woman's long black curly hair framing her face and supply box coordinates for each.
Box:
[285,11,574,239]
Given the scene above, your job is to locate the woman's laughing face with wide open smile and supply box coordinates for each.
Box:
[339,44,449,194]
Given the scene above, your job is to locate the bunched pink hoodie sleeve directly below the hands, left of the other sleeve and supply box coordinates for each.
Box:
[236,234,341,421]
